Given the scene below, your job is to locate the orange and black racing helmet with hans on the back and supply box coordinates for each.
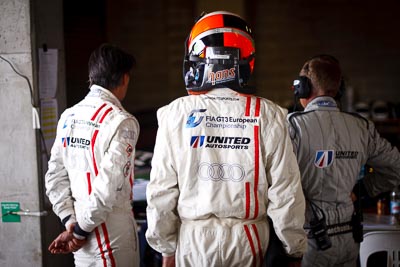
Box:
[183,11,255,94]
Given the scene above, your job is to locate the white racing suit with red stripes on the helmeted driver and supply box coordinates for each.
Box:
[146,88,307,267]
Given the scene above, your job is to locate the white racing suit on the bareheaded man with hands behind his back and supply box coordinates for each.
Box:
[46,85,139,267]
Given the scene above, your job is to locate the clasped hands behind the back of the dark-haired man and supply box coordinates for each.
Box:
[49,225,86,254]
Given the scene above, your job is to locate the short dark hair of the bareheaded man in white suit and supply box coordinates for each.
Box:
[88,44,136,90]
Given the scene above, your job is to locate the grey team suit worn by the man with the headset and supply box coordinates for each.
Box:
[288,97,400,267]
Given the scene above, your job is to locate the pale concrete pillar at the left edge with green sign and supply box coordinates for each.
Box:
[0,0,43,267]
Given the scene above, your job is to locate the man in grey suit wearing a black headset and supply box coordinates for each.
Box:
[288,55,400,267]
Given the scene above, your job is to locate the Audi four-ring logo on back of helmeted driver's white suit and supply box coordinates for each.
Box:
[198,162,246,182]
